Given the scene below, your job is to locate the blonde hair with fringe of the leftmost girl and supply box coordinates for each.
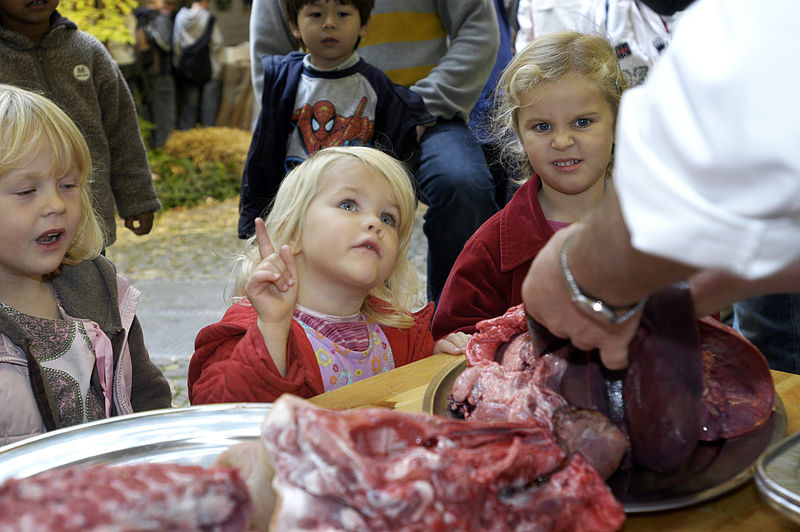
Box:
[0,84,104,273]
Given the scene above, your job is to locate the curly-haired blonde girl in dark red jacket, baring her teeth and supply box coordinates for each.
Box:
[433,31,626,338]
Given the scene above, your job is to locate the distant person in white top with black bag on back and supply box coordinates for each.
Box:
[172,0,224,130]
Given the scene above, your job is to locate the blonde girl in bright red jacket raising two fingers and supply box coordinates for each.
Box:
[188,147,467,404]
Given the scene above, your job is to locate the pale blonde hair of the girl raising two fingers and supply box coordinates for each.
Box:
[233,146,419,328]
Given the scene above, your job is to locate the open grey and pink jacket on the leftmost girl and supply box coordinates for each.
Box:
[0,256,172,445]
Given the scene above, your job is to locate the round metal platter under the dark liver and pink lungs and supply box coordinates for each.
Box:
[422,358,786,513]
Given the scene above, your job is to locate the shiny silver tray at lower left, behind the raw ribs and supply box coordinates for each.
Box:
[0,403,272,482]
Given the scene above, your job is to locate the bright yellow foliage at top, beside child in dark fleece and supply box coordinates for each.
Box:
[58,0,139,44]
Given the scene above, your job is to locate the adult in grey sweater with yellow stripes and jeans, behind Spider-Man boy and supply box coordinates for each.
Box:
[250,0,499,301]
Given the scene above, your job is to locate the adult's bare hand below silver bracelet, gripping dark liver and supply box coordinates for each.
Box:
[522,223,642,370]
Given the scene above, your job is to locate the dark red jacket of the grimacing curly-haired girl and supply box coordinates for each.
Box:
[433,175,553,340]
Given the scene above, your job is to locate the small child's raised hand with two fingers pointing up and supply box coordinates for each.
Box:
[244,218,297,324]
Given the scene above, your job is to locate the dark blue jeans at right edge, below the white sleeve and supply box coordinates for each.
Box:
[733,294,800,373]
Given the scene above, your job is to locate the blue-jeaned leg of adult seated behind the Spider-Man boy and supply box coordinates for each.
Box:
[419,119,497,301]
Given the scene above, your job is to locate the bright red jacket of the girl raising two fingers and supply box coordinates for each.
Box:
[188,303,434,404]
